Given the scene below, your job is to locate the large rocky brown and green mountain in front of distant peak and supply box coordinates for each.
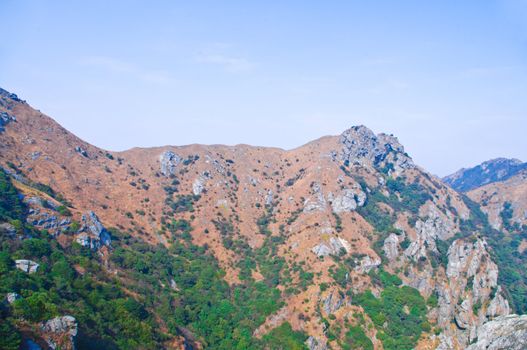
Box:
[0,90,525,350]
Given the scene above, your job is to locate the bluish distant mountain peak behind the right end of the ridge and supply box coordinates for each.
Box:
[443,158,527,192]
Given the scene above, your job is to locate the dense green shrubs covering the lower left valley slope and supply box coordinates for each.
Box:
[0,173,313,349]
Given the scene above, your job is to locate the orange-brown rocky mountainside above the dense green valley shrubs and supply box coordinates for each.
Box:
[0,91,520,349]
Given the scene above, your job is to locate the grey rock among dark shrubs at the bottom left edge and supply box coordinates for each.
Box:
[40,316,77,350]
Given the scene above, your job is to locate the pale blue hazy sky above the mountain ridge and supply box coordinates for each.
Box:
[0,0,527,176]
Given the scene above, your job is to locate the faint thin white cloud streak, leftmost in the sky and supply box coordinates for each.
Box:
[79,56,173,84]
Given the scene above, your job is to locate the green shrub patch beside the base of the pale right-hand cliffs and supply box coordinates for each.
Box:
[353,285,429,350]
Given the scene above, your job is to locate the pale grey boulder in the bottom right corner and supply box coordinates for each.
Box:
[467,315,527,350]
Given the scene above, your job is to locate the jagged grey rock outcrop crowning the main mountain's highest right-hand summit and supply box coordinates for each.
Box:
[340,126,415,173]
